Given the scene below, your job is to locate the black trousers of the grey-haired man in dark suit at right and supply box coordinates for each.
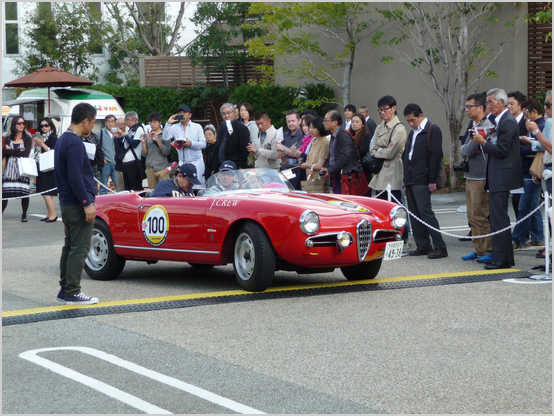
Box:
[489,191,514,263]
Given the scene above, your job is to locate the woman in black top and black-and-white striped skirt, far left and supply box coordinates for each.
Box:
[2,117,33,222]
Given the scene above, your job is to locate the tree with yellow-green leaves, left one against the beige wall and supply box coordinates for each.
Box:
[246,2,387,105]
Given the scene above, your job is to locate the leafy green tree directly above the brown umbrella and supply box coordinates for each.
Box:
[12,2,99,81]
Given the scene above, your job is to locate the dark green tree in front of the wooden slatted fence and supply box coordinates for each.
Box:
[186,2,264,88]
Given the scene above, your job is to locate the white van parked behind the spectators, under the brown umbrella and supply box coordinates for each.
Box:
[2,88,125,136]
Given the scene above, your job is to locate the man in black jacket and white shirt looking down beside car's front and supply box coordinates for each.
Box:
[402,104,448,259]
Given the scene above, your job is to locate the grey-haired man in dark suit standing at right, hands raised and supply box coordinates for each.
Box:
[472,88,524,270]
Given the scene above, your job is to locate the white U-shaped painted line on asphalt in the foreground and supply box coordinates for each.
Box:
[19,347,265,414]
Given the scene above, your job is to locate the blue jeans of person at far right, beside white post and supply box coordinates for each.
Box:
[512,179,544,244]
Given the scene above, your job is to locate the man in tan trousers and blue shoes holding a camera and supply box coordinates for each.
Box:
[454,94,494,263]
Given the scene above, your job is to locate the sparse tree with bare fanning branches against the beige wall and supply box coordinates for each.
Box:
[381,2,519,189]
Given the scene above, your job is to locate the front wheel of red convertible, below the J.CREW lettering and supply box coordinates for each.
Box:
[233,223,275,292]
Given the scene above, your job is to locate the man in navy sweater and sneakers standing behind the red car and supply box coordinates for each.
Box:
[54,103,98,305]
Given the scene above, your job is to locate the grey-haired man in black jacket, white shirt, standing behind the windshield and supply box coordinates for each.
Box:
[217,103,250,169]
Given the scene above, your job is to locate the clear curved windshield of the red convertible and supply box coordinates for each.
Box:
[203,169,294,196]
